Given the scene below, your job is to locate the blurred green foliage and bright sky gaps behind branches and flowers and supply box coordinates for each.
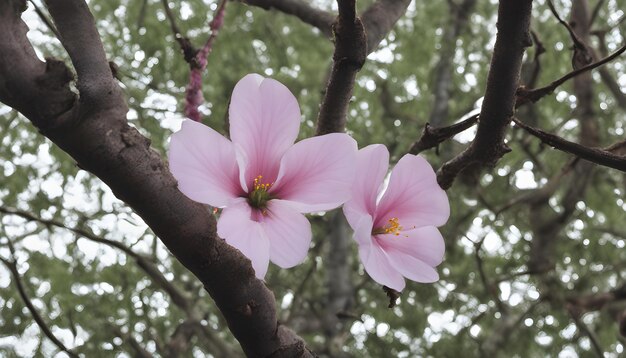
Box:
[0,0,626,357]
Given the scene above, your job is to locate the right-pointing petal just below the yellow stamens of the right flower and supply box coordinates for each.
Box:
[377,226,446,267]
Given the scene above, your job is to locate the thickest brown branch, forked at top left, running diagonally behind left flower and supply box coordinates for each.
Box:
[0,0,311,357]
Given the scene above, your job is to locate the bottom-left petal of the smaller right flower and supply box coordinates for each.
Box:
[359,242,405,291]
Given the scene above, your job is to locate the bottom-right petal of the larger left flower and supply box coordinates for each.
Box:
[263,200,311,268]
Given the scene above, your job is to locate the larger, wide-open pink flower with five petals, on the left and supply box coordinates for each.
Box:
[169,74,357,279]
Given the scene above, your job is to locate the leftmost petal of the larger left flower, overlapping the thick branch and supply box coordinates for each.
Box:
[169,120,243,207]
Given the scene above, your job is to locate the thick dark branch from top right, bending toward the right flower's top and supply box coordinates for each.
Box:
[437,0,532,189]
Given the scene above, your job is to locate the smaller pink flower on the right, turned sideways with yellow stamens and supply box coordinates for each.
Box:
[343,144,450,291]
